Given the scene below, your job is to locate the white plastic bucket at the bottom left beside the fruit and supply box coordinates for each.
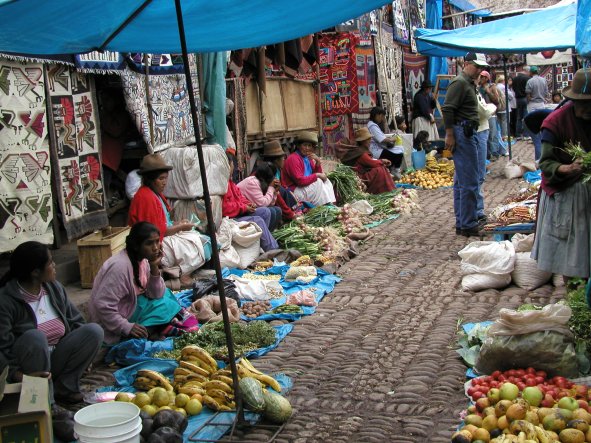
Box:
[74,401,142,443]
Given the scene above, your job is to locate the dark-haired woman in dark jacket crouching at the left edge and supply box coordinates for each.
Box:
[0,241,103,403]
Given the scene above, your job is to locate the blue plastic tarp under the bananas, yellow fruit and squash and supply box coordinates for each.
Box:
[101,360,293,441]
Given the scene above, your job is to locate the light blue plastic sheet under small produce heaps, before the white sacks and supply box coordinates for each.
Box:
[223,265,341,321]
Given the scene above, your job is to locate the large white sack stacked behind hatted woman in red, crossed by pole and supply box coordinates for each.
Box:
[161,145,230,199]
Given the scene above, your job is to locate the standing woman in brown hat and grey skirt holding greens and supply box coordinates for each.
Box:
[532,68,591,278]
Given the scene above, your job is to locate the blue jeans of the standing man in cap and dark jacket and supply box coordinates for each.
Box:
[453,125,479,229]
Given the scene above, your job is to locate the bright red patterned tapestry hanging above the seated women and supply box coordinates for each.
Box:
[318,33,359,116]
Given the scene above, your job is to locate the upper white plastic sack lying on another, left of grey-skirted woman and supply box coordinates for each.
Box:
[458,241,515,275]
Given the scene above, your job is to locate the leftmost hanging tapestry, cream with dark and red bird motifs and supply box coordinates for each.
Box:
[0,60,53,252]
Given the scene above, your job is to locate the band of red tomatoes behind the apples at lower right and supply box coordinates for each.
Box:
[466,368,591,407]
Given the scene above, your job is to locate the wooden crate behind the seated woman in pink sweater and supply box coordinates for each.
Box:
[78,226,130,288]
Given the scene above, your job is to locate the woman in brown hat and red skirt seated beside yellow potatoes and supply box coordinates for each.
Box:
[341,128,394,194]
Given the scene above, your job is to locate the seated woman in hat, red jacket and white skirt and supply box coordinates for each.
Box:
[281,131,336,206]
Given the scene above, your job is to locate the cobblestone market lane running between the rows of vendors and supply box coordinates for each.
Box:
[80,142,564,443]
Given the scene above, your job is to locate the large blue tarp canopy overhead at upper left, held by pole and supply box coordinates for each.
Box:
[0,0,388,54]
